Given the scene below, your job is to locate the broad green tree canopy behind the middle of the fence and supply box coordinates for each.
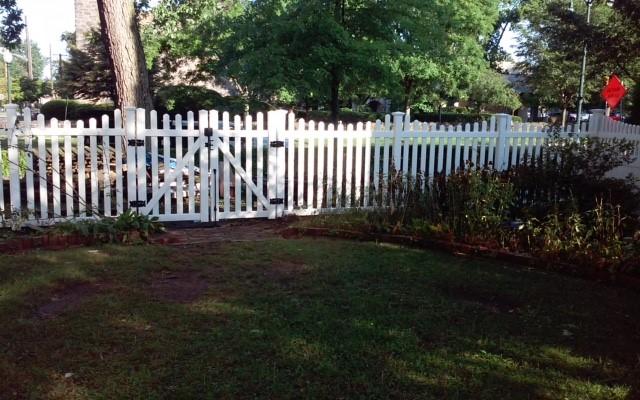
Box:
[148,0,498,117]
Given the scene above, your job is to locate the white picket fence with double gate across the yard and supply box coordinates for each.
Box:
[0,105,640,224]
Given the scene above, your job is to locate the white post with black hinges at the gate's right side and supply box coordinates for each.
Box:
[267,110,287,219]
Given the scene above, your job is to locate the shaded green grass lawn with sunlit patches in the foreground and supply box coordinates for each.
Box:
[0,239,640,400]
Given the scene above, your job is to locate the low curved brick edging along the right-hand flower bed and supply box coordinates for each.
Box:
[282,227,640,291]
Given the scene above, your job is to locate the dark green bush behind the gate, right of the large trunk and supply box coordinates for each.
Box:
[154,85,270,116]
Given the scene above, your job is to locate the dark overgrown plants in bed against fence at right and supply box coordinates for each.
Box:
[298,135,640,273]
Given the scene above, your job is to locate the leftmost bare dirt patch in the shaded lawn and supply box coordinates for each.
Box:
[36,282,105,319]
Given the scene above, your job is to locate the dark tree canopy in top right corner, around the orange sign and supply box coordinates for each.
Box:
[519,0,640,117]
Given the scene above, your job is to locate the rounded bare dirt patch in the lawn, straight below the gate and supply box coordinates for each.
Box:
[151,271,209,303]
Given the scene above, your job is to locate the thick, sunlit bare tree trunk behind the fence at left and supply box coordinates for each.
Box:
[98,0,152,111]
